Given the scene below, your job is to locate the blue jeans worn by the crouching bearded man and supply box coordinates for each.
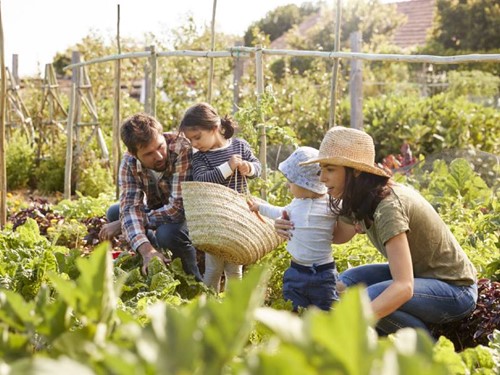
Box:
[106,204,202,281]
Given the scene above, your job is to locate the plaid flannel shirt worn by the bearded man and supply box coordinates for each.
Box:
[119,133,192,251]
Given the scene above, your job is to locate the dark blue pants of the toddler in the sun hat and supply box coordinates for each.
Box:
[283,262,338,311]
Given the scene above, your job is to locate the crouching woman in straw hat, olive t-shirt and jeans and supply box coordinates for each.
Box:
[276,126,477,334]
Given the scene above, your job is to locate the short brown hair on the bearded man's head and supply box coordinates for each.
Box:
[120,113,163,155]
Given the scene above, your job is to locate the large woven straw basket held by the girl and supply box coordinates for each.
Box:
[182,181,283,265]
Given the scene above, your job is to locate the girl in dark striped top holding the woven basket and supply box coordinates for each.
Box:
[179,103,261,292]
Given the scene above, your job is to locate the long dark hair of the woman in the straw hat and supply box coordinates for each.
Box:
[330,167,391,221]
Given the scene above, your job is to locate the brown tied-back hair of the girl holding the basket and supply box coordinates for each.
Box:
[179,103,238,139]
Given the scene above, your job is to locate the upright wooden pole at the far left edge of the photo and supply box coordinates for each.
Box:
[0,2,7,229]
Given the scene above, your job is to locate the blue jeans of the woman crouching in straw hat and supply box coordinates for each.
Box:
[339,264,477,335]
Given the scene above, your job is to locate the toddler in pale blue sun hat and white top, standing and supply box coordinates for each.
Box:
[249,147,338,311]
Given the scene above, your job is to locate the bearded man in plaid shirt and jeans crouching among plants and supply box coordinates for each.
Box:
[99,113,202,281]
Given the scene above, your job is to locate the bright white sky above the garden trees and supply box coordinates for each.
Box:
[0,0,310,77]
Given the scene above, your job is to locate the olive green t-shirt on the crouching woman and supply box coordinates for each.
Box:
[344,184,476,285]
